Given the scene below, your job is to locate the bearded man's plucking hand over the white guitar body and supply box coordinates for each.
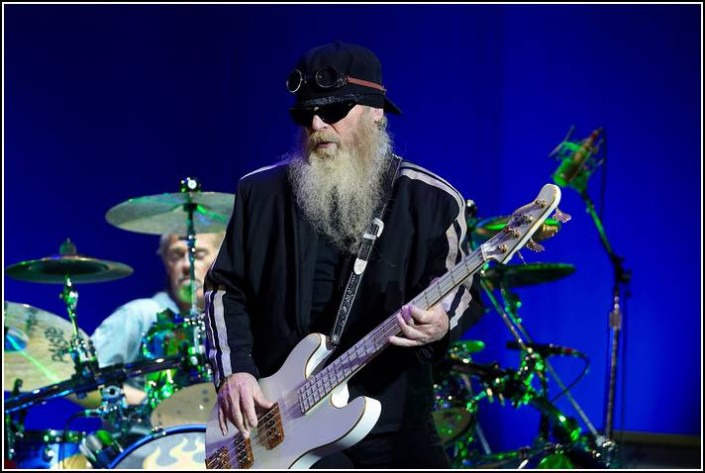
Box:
[218,373,274,438]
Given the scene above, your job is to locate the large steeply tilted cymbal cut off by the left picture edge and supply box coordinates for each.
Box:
[4,301,88,391]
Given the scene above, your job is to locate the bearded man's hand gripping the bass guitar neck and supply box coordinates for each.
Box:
[389,304,450,347]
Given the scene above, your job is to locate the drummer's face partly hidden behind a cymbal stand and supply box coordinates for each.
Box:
[164,233,219,310]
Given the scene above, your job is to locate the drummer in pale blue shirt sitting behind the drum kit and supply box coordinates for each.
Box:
[74,232,225,408]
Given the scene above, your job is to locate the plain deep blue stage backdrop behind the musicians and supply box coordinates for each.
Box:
[3,4,702,451]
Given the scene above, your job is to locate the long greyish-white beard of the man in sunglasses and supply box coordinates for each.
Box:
[289,113,391,253]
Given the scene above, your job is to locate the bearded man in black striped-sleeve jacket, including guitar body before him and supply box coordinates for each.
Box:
[201,42,482,469]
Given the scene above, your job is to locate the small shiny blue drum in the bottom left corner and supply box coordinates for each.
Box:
[12,430,93,470]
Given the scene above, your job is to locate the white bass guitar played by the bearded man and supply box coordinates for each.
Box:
[206,184,561,469]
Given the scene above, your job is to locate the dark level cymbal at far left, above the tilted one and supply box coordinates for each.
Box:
[5,255,132,284]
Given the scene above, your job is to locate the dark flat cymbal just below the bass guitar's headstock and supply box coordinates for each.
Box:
[480,263,575,287]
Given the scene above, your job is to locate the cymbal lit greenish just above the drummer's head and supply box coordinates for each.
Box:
[105,192,235,235]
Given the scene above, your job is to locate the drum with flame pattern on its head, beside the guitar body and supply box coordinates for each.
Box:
[109,425,206,470]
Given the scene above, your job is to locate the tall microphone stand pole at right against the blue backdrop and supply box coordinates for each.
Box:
[578,188,631,464]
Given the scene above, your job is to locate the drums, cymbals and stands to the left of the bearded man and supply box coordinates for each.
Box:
[3,178,235,469]
